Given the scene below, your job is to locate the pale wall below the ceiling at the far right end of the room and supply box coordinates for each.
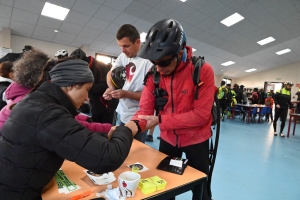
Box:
[234,62,300,95]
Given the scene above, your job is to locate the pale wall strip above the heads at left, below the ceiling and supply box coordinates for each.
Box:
[11,35,95,57]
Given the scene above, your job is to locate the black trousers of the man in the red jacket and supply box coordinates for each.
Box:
[159,139,211,200]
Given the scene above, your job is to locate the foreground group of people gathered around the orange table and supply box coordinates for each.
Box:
[0,19,216,200]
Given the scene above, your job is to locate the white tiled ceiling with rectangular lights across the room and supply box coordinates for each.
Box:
[0,0,300,78]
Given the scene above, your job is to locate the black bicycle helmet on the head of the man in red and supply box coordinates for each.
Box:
[138,19,186,60]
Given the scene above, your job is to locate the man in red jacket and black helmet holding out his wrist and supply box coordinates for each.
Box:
[132,19,216,200]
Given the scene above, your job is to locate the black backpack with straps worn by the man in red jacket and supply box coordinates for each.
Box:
[149,56,219,126]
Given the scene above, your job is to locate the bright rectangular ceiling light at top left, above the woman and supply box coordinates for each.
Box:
[42,2,70,20]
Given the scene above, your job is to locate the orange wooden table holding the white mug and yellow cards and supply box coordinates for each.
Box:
[42,140,207,200]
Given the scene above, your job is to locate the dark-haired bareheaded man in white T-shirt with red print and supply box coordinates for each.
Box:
[103,24,153,143]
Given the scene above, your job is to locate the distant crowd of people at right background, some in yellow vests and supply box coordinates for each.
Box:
[218,80,300,137]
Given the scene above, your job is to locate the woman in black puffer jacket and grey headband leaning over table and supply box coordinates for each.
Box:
[0,59,138,200]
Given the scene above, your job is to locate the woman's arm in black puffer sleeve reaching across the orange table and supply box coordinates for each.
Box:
[37,106,138,174]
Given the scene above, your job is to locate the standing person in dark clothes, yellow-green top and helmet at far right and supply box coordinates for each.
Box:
[273,81,294,137]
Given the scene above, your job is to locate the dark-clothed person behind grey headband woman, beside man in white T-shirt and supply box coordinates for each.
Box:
[70,49,119,124]
